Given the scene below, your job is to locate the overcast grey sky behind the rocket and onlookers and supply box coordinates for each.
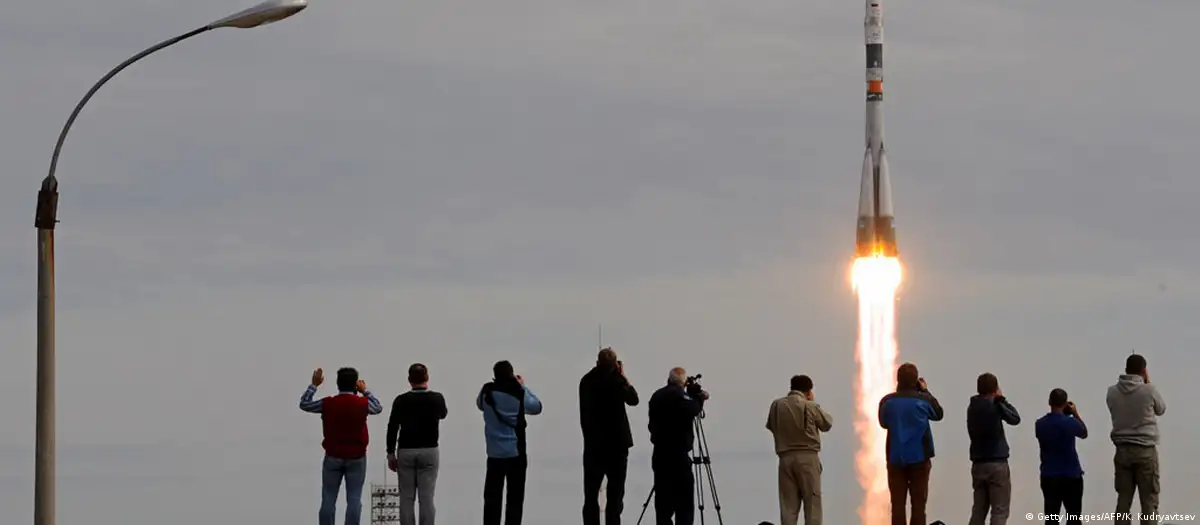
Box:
[0,0,1200,525]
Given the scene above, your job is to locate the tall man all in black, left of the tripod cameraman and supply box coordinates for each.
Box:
[580,348,638,525]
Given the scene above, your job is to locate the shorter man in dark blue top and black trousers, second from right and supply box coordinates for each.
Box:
[1034,388,1087,525]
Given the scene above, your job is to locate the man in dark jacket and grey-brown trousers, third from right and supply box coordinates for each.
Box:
[967,373,1021,525]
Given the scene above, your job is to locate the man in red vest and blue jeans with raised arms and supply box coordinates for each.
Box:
[300,368,383,525]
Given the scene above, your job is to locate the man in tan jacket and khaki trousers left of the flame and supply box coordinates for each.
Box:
[767,375,833,525]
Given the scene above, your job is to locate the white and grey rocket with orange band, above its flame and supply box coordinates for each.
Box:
[854,0,900,257]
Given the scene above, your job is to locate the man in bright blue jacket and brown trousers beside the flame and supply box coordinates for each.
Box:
[880,363,944,525]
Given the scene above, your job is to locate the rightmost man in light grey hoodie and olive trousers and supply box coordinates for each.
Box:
[1108,354,1166,525]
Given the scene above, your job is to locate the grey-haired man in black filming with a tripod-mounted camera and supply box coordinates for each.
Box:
[649,367,708,525]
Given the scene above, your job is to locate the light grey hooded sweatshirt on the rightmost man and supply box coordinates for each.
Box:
[1108,374,1166,447]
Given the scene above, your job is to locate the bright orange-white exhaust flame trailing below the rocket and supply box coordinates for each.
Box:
[851,255,902,525]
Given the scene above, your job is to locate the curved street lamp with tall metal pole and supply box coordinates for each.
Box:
[34,0,308,525]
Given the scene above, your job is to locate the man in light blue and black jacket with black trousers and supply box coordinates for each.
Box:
[475,361,541,525]
